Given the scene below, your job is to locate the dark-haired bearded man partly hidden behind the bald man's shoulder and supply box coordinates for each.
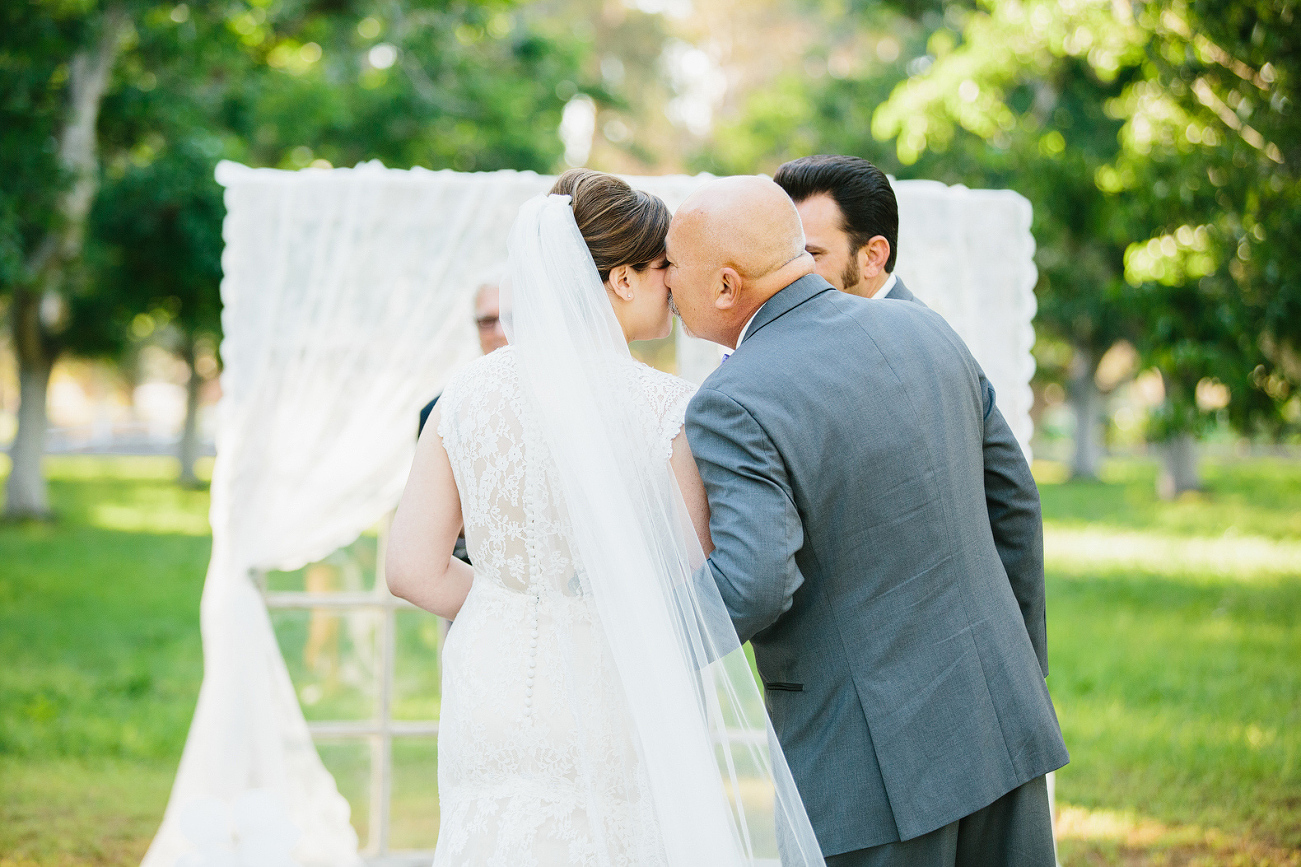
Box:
[773,155,921,303]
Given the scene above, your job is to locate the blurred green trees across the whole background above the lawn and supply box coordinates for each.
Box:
[0,0,1301,502]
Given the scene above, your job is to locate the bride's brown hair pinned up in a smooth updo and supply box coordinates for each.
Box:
[552,169,671,281]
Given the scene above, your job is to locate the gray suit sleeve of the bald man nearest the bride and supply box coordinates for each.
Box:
[686,388,804,642]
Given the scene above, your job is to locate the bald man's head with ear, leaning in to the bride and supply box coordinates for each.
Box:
[666,176,813,346]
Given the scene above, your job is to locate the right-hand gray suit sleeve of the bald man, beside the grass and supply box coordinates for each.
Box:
[980,372,1049,677]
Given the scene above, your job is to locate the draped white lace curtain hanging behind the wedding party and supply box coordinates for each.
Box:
[144,163,1036,867]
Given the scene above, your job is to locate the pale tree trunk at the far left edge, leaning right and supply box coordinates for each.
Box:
[5,3,130,518]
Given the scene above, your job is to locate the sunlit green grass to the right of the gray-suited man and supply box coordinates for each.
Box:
[1038,461,1301,864]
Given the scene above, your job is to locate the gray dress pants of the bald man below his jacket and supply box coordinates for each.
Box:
[826,777,1056,867]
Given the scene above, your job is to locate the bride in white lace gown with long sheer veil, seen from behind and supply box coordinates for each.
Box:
[386,169,822,867]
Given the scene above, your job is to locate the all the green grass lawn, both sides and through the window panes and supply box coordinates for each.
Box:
[0,447,1301,867]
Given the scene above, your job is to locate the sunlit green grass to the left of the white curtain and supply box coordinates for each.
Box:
[0,457,211,867]
